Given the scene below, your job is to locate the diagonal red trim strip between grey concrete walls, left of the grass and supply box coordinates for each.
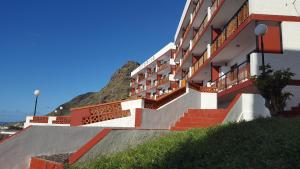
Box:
[69,128,112,164]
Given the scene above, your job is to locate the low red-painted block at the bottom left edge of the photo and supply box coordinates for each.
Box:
[29,157,64,169]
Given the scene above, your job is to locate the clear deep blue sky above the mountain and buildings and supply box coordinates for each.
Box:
[0,0,185,121]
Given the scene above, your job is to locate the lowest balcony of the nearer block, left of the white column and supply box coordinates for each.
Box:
[211,61,250,92]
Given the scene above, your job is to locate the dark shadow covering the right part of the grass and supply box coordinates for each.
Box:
[146,119,300,169]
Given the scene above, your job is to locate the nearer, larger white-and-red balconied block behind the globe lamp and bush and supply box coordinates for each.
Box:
[174,0,300,106]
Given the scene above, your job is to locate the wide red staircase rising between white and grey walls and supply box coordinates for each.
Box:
[171,109,228,131]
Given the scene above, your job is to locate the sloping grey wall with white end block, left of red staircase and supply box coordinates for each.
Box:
[141,88,217,129]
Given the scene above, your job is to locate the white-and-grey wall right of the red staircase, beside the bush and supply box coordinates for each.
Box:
[223,94,271,123]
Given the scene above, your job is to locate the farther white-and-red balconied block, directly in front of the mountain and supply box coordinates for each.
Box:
[130,43,179,99]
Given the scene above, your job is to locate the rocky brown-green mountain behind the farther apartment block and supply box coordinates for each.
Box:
[48,61,140,116]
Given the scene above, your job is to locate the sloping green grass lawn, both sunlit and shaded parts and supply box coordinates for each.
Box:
[70,118,300,169]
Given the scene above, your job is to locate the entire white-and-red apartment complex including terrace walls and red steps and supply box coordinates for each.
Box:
[25,0,300,130]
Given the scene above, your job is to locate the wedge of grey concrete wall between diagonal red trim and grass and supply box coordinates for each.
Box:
[77,130,170,163]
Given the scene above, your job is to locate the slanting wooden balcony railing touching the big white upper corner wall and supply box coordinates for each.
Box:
[211,1,249,55]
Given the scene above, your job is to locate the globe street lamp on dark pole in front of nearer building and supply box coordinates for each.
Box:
[254,24,268,76]
